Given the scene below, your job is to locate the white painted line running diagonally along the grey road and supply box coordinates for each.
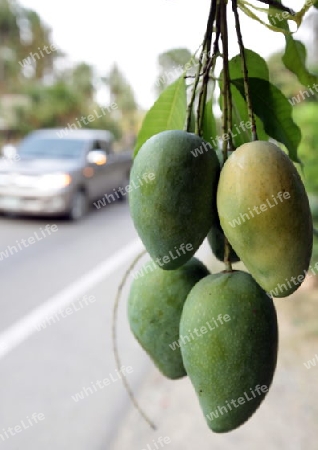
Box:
[0,239,144,359]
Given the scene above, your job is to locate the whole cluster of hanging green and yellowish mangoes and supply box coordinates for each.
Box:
[128,130,312,432]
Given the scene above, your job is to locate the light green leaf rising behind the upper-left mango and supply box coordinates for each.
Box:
[134,76,187,157]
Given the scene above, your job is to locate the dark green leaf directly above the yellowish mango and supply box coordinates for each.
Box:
[232,78,301,162]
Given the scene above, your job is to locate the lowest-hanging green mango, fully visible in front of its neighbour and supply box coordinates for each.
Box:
[180,271,278,433]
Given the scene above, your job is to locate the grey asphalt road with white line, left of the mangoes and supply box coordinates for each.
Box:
[0,203,150,450]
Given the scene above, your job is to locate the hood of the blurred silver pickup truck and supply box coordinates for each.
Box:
[0,158,81,175]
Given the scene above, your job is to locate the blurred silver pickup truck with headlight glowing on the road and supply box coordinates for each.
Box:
[0,129,132,220]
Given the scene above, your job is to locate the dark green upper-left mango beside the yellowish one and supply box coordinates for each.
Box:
[129,130,220,270]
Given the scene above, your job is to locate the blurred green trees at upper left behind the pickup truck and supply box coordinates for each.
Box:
[0,0,124,142]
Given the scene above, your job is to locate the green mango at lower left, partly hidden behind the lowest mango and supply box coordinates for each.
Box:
[128,258,210,379]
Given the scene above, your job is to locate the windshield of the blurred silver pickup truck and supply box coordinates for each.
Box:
[18,136,86,159]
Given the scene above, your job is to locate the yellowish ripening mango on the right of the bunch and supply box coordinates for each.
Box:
[217,141,313,297]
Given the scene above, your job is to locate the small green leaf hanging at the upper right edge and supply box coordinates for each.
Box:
[282,36,318,86]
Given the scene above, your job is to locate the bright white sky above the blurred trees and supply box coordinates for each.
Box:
[19,0,312,108]
